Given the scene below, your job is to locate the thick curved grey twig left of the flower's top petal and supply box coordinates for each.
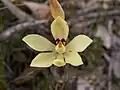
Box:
[0,20,47,42]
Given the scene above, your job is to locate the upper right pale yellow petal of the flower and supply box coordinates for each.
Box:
[66,35,92,52]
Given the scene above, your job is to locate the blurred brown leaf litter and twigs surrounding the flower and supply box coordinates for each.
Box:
[0,0,120,90]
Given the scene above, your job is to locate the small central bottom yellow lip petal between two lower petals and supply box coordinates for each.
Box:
[53,54,66,67]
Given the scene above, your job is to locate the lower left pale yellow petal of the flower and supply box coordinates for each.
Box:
[30,53,55,67]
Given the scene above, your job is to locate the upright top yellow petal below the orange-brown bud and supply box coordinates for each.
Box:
[51,16,69,40]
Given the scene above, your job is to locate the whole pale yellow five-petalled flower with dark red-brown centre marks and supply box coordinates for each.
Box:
[23,16,92,67]
